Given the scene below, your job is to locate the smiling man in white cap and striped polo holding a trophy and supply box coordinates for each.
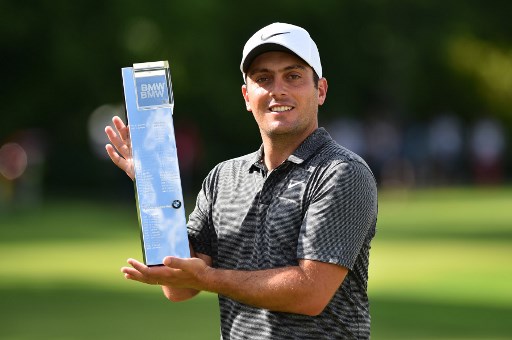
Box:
[106,23,377,340]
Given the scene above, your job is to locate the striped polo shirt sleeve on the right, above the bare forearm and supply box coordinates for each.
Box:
[297,161,377,270]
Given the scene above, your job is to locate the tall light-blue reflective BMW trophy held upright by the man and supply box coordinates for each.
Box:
[122,61,190,266]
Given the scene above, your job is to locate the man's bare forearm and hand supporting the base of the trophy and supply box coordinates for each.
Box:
[123,254,348,315]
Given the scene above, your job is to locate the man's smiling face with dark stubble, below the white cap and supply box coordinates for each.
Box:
[242,52,327,138]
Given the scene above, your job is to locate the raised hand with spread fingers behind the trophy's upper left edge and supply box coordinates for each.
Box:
[105,116,135,180]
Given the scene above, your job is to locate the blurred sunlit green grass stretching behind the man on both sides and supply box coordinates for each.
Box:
[0,188,512,339]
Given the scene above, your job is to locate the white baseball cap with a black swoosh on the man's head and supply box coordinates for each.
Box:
[240,22,322,80]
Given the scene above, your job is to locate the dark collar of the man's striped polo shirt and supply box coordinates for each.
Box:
[248,128,332,170]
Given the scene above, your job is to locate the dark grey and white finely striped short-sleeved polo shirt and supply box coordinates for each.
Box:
[188,128,377,340]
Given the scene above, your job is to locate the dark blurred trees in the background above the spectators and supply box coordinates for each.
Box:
[0,0,512,197]
